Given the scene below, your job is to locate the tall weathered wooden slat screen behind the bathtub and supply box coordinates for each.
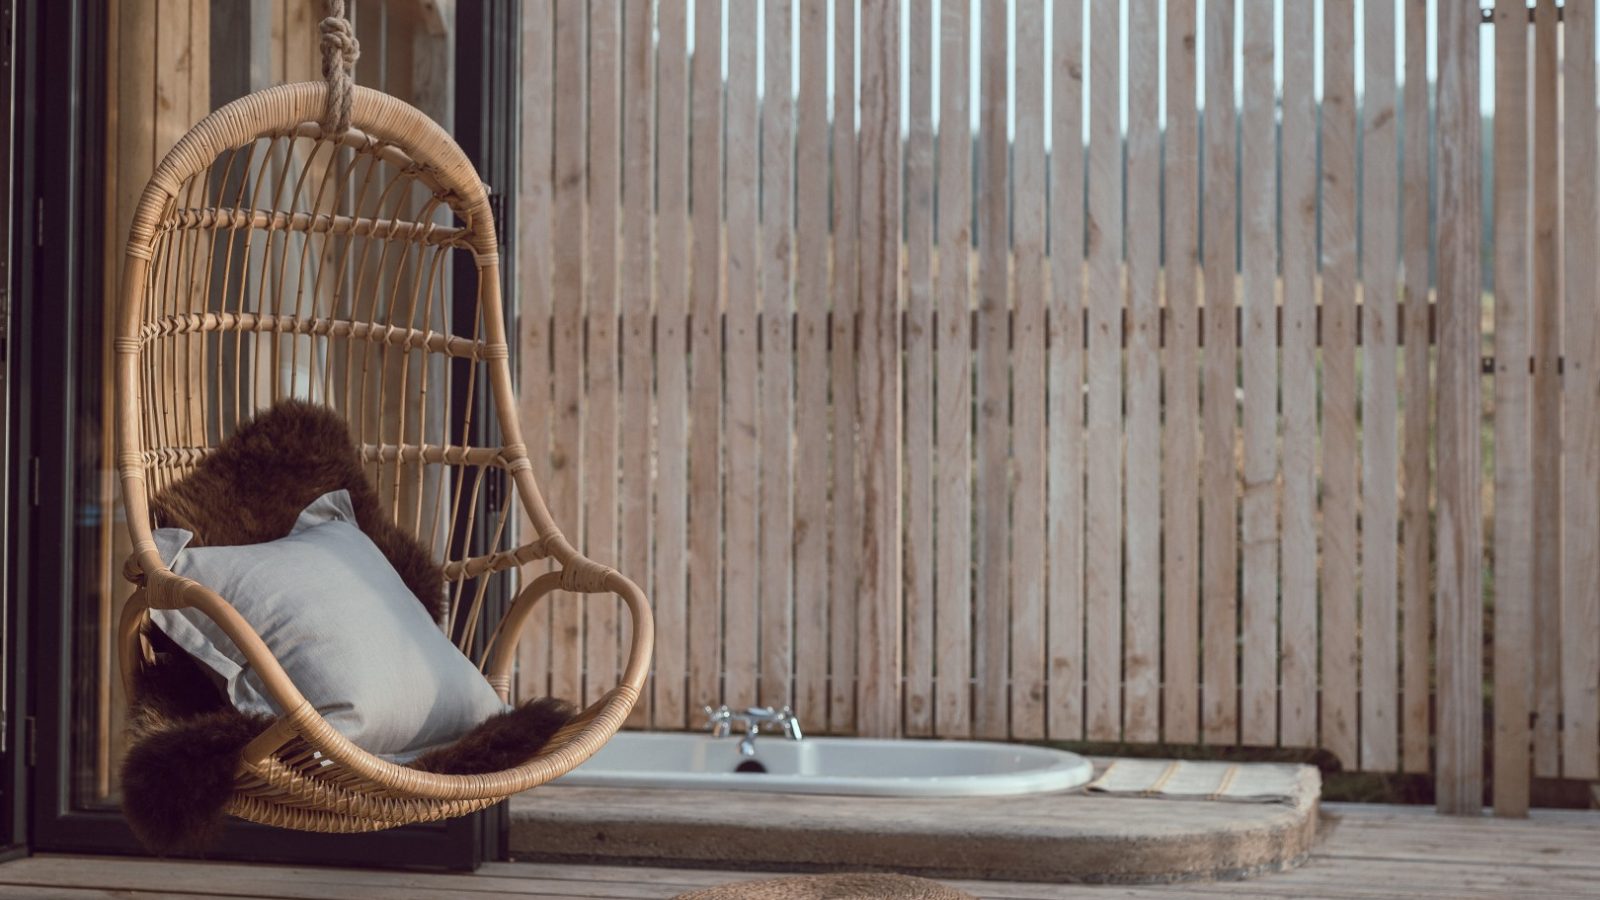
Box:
[517,0,1600,814]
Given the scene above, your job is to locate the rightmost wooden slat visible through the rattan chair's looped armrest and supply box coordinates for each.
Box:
[582,0,622,705]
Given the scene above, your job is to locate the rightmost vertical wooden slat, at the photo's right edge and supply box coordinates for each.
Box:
[1561,3,1600,780]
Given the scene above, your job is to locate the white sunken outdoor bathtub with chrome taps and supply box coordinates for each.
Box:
[557,732,1093,798]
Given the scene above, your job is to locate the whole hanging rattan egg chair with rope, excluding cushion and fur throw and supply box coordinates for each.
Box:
[115,3,653,833]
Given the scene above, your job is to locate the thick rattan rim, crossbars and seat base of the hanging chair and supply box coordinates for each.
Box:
[115,82,653,833]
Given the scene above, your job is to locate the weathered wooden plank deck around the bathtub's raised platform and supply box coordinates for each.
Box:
[0,804,1600,900]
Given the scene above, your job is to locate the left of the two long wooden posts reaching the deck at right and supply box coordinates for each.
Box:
[1435,3,1484,815]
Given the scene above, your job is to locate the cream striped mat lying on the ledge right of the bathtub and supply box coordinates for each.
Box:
[1088,759,1306,804]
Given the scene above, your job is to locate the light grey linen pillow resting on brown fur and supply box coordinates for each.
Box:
[150,490,507,762]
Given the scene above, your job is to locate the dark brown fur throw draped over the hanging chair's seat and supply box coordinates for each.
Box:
[122,400,573,854]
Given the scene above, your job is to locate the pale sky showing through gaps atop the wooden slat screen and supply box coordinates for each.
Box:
[688,0,1494,146]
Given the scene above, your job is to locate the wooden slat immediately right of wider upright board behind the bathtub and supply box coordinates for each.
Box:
[904,0,936,737]
